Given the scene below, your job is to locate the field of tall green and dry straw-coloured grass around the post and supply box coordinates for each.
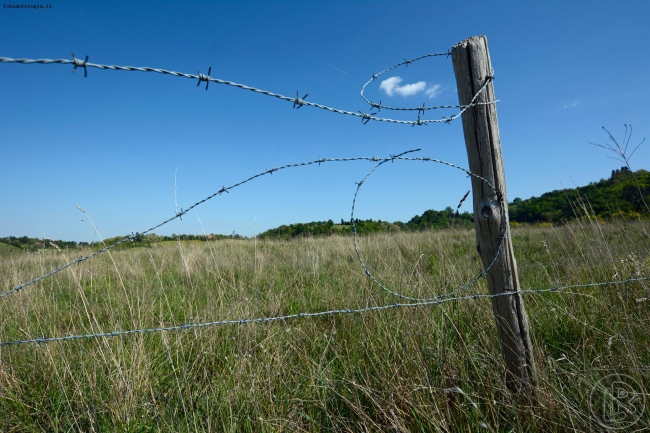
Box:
[0,221,650,432]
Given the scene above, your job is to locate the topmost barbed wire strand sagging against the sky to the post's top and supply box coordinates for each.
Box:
[0,53,498,126]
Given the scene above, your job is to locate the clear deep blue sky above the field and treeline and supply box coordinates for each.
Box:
[0,0,650,241]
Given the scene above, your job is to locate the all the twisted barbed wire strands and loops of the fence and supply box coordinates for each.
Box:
[0,52,650,347]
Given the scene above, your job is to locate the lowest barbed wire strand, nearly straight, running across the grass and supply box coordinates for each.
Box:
[0,277,650,347]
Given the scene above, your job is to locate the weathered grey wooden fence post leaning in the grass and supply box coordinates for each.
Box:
[451,36,537,390]
